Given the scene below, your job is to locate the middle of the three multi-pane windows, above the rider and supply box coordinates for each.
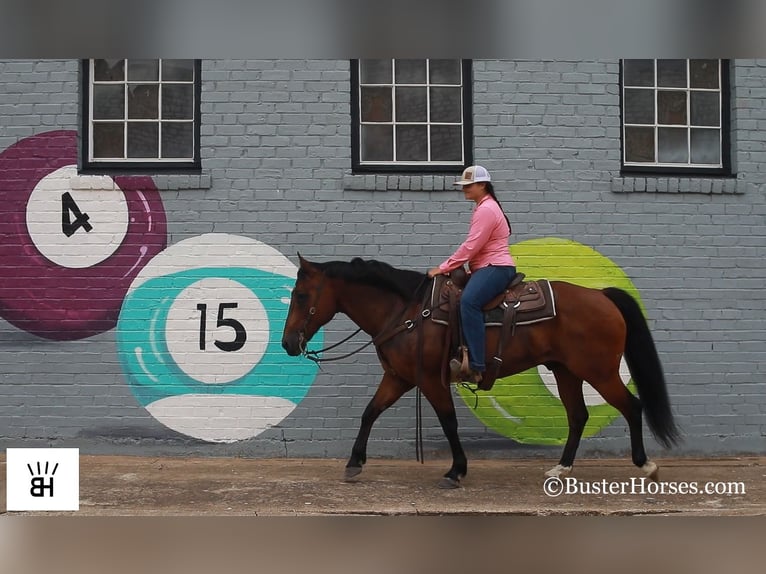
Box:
[351,60,472,173]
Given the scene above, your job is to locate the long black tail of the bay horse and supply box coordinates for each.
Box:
[603,287,680,448]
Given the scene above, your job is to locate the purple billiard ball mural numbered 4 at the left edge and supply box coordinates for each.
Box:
[0,131,167,340]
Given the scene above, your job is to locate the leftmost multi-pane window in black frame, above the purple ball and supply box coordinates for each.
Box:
[82,60,201,171]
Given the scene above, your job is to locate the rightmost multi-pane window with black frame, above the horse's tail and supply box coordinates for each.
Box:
[622,60,730,174]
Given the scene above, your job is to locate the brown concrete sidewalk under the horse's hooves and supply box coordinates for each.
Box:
[0,455,766,516]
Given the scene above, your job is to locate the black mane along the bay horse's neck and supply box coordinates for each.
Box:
[314,257,428,301]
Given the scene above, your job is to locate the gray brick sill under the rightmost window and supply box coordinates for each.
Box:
[612,175,755,195]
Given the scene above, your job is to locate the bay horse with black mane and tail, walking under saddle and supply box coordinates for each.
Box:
[282,254,678,488]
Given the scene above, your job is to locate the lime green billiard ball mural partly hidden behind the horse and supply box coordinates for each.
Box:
[458,237,641,445]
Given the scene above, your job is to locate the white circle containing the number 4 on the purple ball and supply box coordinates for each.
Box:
[26,165,128,269]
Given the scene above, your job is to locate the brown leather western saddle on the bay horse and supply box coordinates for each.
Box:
[431,269,556,390]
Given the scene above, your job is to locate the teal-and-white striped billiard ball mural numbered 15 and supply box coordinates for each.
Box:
[117,233,323,443]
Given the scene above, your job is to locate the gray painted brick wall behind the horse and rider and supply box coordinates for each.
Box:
[0,60,766,464]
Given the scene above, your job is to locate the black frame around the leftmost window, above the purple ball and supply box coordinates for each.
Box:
[78,58,202,175]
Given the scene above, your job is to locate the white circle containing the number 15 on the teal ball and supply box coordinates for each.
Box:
[165,277,269,385]
